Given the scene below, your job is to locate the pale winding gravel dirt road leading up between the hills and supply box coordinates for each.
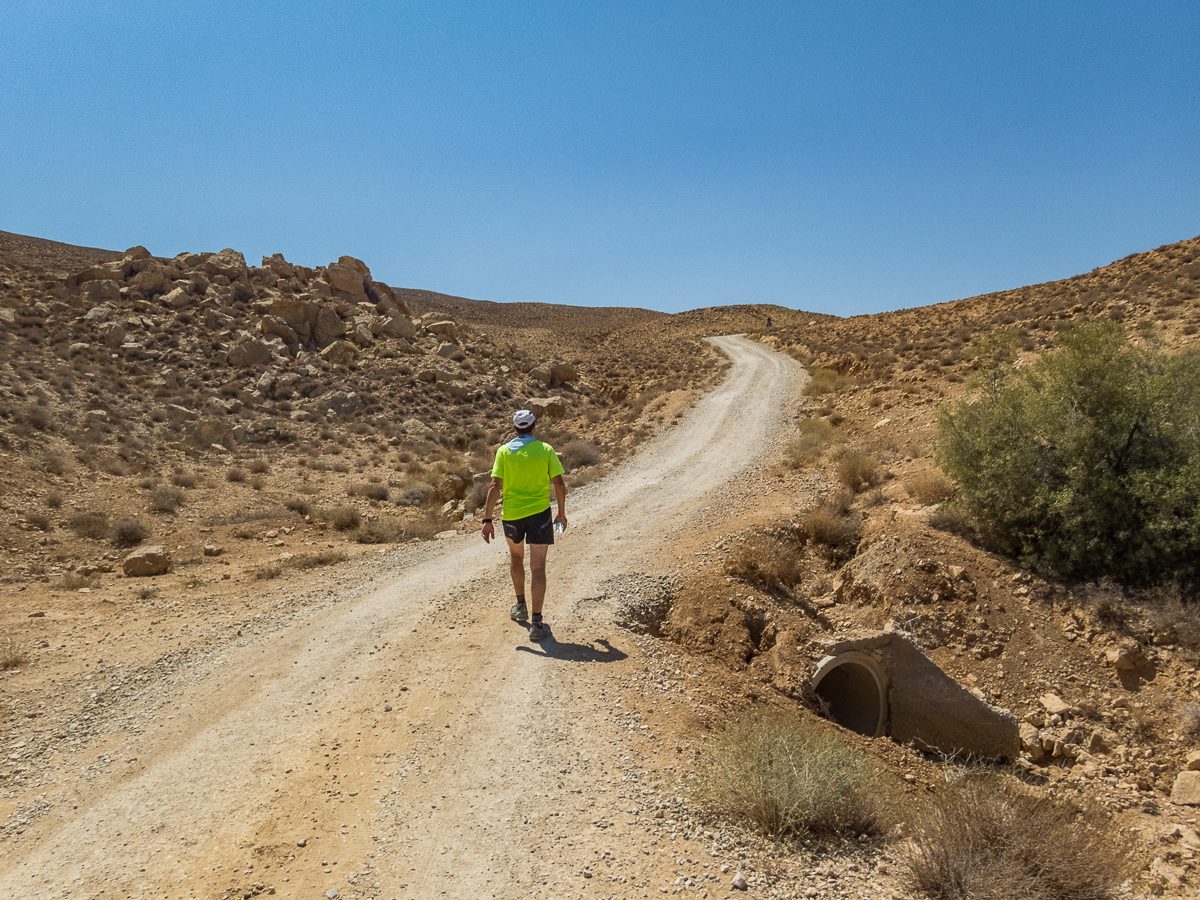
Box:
[0,337,802,898]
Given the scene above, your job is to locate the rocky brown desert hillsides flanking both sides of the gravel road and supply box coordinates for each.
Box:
[0,232,1200,895]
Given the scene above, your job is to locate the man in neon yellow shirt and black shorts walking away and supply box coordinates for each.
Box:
[484,409,566,641]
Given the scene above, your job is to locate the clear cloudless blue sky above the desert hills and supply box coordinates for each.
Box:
[0,0,1200,316]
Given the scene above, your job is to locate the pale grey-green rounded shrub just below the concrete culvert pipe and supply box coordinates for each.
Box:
[694,713,883,835]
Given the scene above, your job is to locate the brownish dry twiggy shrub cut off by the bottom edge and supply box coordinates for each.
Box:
[901,776,1132,900]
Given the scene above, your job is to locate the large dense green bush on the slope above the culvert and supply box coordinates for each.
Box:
[937,322,1200,588]
